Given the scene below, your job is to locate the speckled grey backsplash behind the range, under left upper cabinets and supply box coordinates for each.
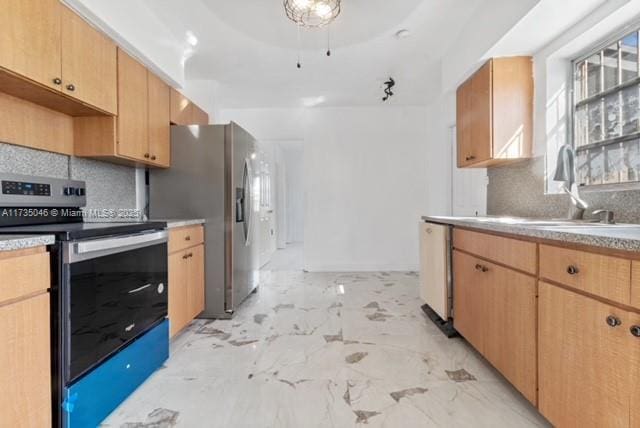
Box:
[0,143,136,221]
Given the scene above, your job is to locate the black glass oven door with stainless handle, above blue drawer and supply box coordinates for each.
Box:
[63,231,168,384]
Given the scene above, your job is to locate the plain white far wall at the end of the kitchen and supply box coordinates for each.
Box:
[221,102,450,271]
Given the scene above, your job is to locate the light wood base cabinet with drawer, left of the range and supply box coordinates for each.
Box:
[0,247,52,428]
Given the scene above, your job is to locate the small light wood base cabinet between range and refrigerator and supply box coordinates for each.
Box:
[169,227,205,337]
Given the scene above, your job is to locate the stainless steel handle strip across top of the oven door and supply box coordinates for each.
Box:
[67,230,168,263]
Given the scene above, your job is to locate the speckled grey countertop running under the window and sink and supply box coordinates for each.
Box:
[422,216,640,252]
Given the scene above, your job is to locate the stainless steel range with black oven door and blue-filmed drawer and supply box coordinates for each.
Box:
[0,174,169,428]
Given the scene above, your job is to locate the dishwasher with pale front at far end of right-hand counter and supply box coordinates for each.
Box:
[419,222,457,337]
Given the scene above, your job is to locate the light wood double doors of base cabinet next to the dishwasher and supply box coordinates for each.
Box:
[453,251,537,404]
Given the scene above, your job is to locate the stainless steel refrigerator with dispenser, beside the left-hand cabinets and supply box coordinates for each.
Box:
[149,122,260,318]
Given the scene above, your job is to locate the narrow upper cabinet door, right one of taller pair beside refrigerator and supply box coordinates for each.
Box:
[148,72,171,167]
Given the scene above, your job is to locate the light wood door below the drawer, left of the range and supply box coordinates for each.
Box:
[0,293,51,427]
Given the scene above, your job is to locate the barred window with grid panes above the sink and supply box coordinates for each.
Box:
[573,31,640,186]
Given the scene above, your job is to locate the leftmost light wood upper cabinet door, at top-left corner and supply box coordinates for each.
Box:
[0,0,62,90]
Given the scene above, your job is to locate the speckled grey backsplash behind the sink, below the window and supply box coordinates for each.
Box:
[487,157,640,223]
